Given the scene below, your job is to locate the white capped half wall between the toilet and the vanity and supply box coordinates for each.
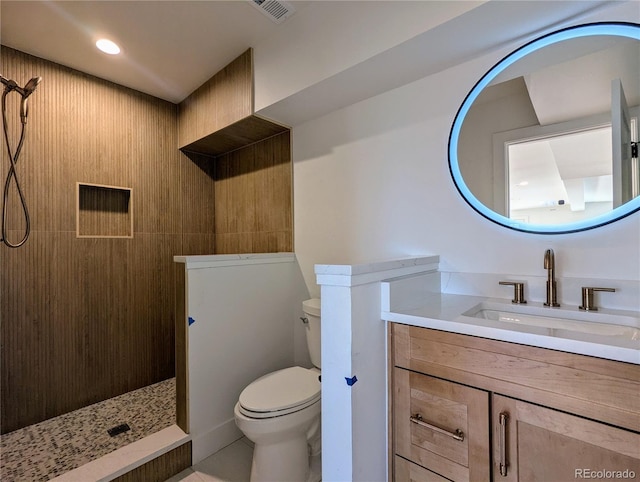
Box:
[315,256,440,482]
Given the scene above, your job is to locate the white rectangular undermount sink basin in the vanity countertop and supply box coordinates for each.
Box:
[462,302,640,342]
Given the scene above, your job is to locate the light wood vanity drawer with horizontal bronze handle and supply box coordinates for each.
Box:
[393,367,490,482]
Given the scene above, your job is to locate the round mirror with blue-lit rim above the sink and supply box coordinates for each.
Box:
[449,23,640,234]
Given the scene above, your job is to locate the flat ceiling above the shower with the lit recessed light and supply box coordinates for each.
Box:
[0,0,305,103]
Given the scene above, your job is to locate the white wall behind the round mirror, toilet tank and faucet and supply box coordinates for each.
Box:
[293,4,640,304]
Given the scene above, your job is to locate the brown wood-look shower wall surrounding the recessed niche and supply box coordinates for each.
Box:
[0,46,214,433]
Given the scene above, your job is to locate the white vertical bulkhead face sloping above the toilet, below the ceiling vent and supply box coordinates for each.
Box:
[253,0,486,111]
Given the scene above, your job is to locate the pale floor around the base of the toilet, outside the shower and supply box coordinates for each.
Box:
[167,437,322,482]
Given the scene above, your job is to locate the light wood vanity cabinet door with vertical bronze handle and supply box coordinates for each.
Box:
[492,394,640,482]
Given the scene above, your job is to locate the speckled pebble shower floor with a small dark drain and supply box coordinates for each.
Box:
[0,378,176,482]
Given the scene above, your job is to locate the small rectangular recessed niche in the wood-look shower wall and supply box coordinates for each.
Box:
[76,182,133,238]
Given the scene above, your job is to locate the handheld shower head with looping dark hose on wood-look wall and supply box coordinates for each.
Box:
[0,75,42,248]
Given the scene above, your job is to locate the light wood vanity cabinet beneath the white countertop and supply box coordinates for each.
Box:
[390,323,640,482]
